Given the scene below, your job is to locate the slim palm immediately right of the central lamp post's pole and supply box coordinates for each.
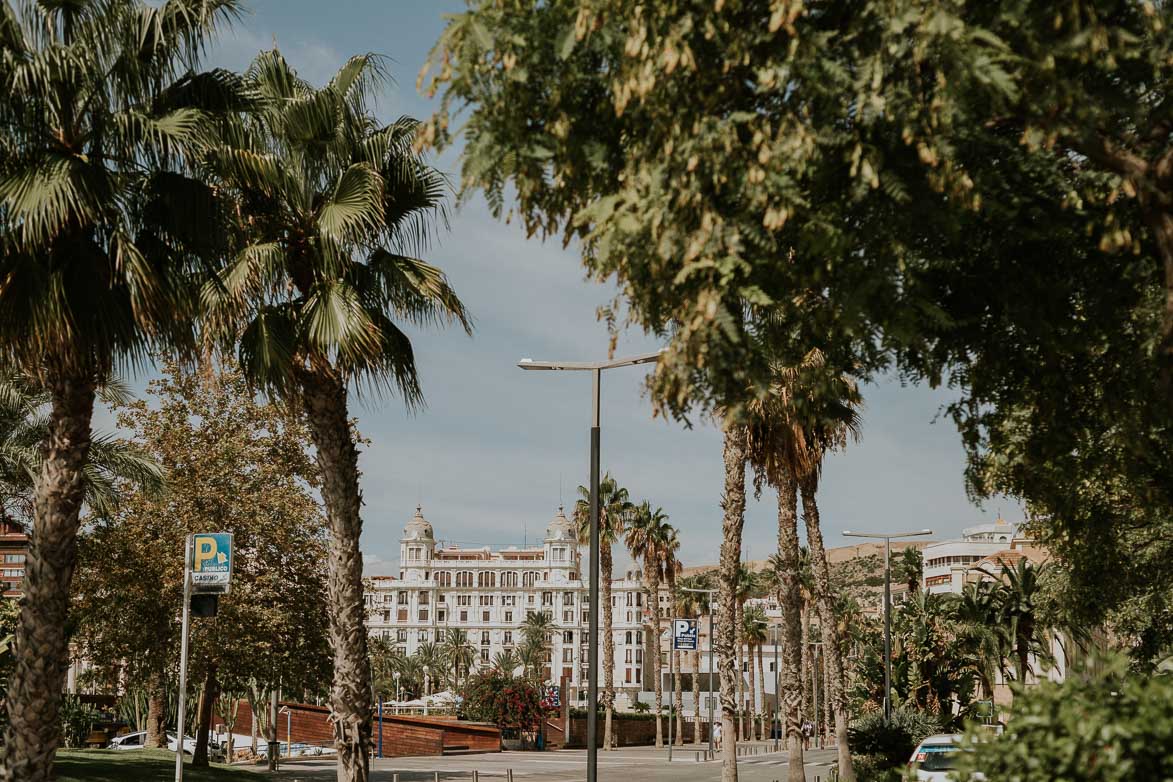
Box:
[574,472,635,750]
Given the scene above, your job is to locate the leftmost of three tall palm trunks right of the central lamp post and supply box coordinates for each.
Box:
[716,423,745,782]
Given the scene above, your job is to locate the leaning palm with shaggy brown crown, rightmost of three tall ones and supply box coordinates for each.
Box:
[748,351,861,782]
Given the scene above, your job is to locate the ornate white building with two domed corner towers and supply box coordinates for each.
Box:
[366,508,644,708]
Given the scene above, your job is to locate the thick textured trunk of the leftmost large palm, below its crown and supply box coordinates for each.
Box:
[2,368,94,782]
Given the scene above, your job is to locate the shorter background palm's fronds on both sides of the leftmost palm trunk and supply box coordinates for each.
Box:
[0,370,163,526]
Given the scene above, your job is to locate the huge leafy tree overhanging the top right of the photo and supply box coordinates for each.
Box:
[421,0,1173,662]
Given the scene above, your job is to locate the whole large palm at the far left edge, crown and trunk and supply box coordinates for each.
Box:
[0,0,245,782]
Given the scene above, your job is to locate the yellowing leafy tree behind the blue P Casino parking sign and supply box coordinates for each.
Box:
[72,363,328,759]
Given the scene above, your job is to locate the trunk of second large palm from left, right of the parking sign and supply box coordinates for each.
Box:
[299,363,371,782]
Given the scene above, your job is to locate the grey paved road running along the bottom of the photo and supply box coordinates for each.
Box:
[260,747,835,782]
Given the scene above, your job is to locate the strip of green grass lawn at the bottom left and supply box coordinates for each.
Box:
[54,749,257,782]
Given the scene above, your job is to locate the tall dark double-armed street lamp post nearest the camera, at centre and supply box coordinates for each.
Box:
[517,351,663,782]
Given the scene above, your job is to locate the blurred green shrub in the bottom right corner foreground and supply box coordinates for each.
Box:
[963,659,1173,782]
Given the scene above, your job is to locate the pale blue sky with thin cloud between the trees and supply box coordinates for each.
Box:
[119,0,1018,573]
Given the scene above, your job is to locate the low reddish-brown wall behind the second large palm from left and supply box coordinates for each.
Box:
[222,701,501,757]
